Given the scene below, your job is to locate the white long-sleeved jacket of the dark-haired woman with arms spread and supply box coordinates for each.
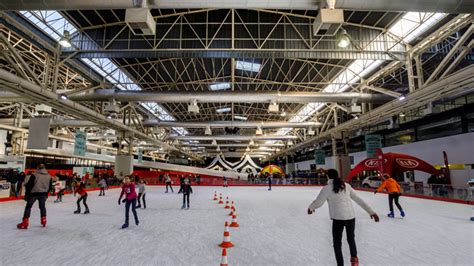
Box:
[309,179,375,220]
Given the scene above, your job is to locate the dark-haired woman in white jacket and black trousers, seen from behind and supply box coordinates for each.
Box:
[308,169,379,266]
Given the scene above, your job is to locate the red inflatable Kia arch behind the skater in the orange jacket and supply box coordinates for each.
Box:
[346,149,438,181]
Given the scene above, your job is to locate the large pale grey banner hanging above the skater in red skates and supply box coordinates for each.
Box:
[26,117,51,150]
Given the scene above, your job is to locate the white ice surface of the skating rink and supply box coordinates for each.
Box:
[0,187,474,265]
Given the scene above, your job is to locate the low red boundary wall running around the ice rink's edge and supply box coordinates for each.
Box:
[0,184,474,205]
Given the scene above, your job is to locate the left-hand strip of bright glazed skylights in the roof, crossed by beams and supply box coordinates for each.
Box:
[20,10,188,135]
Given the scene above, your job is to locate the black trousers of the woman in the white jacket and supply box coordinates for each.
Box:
[332,218,357,266]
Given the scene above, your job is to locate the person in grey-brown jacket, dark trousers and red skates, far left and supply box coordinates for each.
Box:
[16,164,52,229]
